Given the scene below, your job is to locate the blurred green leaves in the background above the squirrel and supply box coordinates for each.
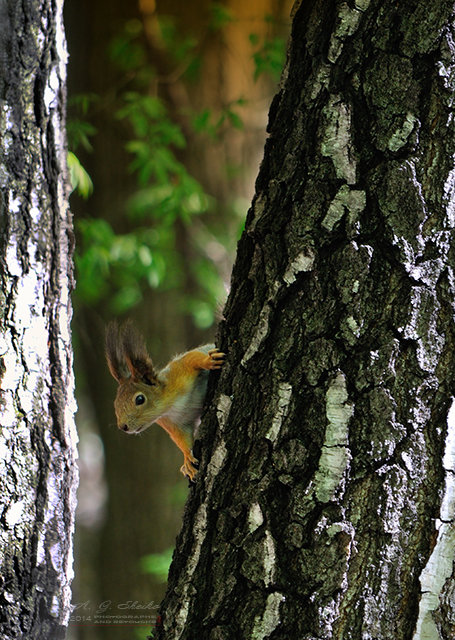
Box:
[68,11,284,328]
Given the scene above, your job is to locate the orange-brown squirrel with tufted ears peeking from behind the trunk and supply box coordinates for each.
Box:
[106,322,225,482]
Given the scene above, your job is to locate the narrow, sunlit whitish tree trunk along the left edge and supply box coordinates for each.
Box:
[0,0,77,640]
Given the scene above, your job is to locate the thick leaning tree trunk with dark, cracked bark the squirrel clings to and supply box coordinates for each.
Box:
[158,0,455,640]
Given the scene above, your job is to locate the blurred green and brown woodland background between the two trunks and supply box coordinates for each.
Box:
[65,0,292,640]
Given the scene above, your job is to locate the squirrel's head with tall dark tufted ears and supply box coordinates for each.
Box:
[106,322,163,433]
